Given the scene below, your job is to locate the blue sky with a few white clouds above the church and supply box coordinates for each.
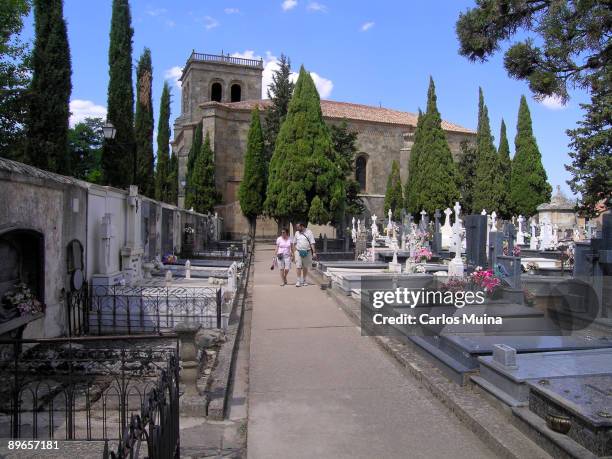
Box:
[24,0,588,194]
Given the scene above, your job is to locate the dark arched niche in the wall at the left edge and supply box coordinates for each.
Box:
[0,229,45,323]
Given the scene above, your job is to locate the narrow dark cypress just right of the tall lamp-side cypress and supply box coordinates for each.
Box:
[135,48,154,197]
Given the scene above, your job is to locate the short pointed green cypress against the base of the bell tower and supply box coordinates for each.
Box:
[187,132,221,213]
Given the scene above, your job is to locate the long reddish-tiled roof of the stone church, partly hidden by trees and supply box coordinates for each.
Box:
[208,99,475,134]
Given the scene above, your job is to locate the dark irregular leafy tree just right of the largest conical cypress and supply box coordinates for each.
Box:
[330,120,365,215]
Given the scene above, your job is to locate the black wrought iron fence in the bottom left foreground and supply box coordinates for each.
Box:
[0,335,179,458]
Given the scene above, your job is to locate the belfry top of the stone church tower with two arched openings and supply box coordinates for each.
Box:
[181,51,263,122]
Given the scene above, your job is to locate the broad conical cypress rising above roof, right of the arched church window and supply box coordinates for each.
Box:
[413,77,459,213]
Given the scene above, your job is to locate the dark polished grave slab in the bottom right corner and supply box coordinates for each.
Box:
[528,374,612,456]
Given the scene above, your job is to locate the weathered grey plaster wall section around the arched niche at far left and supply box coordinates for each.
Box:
[0,164,87,338]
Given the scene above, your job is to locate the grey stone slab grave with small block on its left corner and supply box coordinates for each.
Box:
[472,348,612,406]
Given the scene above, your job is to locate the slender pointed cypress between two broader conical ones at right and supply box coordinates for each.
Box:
[472,88,505,213]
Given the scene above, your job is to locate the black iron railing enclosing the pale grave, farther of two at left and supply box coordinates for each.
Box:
[85,285,222,335]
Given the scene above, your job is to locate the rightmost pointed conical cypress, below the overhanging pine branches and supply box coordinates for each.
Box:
[510,96,552,216]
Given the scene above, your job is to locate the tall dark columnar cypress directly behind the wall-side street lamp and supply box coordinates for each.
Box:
[102,0,136,187]
